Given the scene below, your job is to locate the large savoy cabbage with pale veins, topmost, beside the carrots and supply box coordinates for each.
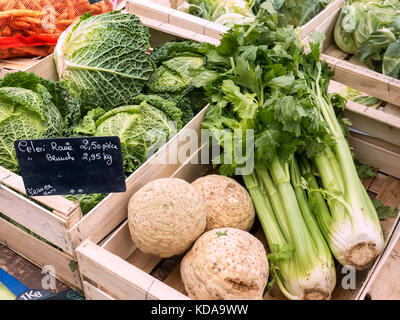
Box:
[55,11,154,111]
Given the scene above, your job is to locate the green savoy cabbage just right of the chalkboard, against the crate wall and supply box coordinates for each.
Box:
[74,94,182,174]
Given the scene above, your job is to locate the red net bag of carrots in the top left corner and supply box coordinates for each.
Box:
[0,0,117,59]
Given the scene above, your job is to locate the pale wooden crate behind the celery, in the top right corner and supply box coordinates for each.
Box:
[304,7,400,109]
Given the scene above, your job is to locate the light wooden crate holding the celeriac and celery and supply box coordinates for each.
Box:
[76,98,400,300]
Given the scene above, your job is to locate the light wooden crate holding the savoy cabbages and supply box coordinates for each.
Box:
[0,32,205,289]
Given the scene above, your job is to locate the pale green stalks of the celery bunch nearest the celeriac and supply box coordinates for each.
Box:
[243,156,336,299]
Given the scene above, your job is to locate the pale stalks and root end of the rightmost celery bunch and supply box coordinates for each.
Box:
[309,62,384,270]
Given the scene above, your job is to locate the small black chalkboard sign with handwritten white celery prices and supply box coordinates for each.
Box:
[14,137,126,196]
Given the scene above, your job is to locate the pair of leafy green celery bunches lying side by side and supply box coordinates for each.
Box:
[188,4,384,299]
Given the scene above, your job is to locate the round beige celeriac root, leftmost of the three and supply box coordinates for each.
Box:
[128,178,206,258]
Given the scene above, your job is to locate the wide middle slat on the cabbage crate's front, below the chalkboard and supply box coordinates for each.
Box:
[0,185,73,254]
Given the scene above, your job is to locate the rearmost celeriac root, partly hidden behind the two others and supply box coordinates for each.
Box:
[192,174,255,231]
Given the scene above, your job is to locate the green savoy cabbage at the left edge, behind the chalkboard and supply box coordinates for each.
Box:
[0,72,80,172]
